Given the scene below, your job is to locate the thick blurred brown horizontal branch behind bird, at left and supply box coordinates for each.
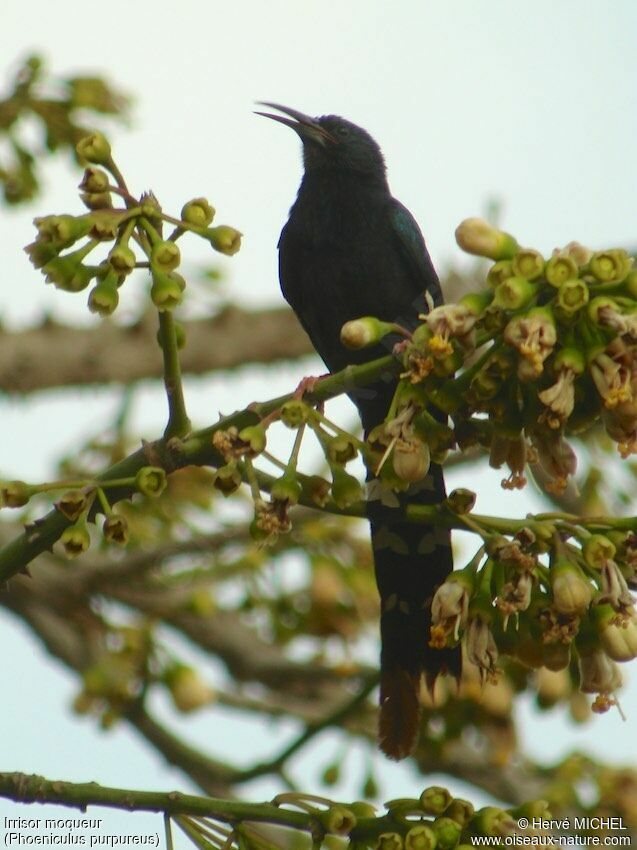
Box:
[0,306,313,393]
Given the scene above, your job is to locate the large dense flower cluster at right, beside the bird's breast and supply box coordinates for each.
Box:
[343,219,637,493]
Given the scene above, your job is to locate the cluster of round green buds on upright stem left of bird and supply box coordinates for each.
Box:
[25,132,241,317]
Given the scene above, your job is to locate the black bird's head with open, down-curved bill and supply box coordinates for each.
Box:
[257,102,385,175]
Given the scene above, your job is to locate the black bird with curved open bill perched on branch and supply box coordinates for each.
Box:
[259,103,460,759]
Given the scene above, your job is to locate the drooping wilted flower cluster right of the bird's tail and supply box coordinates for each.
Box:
[429,520,637,712]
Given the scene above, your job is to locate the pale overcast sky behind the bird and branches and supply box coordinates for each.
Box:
[0,0,637,831]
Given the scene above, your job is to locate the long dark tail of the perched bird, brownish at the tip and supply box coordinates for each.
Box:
[359,394,461,760]
